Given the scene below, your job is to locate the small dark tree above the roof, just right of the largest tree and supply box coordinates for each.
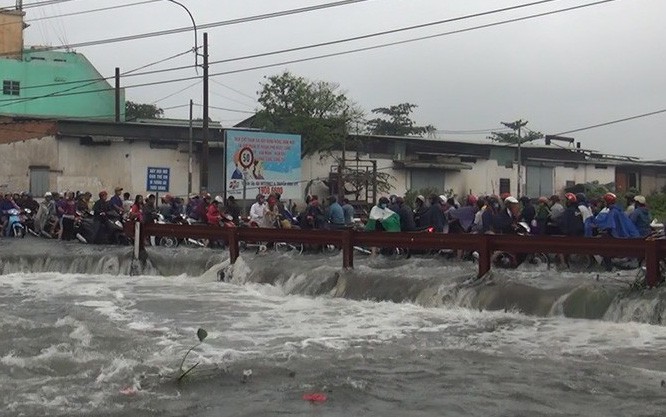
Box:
[360,103,435,136]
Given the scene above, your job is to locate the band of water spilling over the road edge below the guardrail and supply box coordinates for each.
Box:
[0,237,666,324]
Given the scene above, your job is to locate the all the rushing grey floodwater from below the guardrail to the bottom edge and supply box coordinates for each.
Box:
[0,239,666,417]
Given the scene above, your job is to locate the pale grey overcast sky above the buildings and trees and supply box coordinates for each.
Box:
[6,0,666,159]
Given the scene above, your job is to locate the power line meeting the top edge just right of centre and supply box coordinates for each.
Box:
[0,0,370,56]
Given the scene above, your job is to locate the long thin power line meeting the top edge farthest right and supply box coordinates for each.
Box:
[0,0,616,107]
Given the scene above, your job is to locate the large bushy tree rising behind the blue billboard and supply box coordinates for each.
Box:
[254,72,363,157]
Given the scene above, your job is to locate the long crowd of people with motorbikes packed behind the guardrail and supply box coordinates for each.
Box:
[0,187,651,249]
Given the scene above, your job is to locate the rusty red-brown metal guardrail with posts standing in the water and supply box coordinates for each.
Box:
[125,223,666,287]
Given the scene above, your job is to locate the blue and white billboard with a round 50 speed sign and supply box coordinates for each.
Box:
[225,130,302,199]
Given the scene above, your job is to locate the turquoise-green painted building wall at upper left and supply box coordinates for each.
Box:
[0,50,125,120]
